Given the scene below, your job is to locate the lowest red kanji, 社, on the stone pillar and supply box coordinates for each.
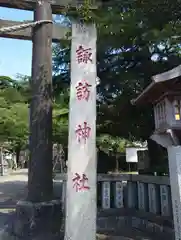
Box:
[72,173,90,192]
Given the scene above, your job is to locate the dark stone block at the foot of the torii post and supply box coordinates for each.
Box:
[6,200,63,240]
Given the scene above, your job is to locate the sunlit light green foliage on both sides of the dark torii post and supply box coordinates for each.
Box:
[0,75,68,153]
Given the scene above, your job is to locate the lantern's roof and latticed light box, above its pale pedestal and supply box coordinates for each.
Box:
[132,65,181,144]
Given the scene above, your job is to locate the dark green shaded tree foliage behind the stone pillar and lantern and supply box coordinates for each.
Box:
[53,0,180,140]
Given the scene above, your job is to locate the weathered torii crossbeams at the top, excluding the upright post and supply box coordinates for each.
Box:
[0,0,101,42]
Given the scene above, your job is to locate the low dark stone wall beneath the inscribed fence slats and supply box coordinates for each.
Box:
[61,209,175,240]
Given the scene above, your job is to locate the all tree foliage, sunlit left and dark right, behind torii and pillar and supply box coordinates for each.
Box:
[0,0,181,172]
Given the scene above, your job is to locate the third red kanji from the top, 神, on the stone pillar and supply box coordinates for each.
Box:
[75,122,91,143]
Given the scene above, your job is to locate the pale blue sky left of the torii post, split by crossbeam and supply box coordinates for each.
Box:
[0,7,33,79]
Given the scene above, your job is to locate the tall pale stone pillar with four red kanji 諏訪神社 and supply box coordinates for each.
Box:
[65,24,97,240]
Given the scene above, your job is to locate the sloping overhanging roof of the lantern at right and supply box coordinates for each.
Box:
[131,65,181,105]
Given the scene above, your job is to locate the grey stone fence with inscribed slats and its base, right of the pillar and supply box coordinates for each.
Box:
[56,174,174,240]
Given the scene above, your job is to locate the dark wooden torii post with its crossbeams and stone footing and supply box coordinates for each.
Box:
[0,0,100,240]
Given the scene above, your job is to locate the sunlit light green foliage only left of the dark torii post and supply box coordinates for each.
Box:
[0,76,28,148]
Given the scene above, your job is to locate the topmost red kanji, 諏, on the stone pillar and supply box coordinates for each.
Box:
[76,45,92,64]
